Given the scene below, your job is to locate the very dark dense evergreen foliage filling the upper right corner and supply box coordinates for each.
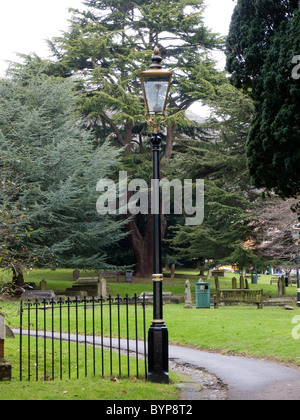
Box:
[227,0,300,197]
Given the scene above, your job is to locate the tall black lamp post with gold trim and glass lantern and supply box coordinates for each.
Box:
[141,47,172,383]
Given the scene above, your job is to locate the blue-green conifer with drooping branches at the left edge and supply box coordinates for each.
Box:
[0,74,124,283]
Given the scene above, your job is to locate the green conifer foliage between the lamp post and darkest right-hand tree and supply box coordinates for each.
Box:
[166,85,257,265]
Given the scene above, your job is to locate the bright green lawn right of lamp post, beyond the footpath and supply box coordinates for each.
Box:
[164,305,300,366]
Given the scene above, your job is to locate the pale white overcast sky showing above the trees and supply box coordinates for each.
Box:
[0,0,235,77]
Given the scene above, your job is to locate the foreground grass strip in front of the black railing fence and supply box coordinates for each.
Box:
[0,338,179,401]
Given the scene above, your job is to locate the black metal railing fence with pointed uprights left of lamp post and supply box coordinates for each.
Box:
[19,294,147,381]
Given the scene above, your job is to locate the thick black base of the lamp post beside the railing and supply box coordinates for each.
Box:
[148,320,169,384]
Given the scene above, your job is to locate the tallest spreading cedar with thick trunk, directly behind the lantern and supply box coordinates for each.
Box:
[46,0,224,277]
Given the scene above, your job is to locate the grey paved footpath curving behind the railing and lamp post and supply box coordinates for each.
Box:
[14,330,300,400]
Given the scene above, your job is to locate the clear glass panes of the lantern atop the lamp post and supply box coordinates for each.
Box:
[144,75,170,114]
